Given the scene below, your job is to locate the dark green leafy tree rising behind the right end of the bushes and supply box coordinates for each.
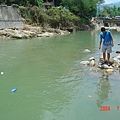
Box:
[62,0,98,20]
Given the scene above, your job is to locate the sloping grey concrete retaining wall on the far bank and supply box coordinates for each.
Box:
[0,5,23,29]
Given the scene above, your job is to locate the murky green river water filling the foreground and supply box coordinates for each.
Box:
[0,31,120,120]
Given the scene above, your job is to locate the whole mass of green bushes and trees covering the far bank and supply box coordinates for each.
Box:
[0,0,110,28]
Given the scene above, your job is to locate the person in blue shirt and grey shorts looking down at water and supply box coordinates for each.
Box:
[99,27,114,62]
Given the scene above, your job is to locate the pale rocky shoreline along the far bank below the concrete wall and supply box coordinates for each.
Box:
[0,25,69,39]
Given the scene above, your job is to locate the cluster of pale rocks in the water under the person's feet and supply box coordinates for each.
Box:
[80,54,120,75]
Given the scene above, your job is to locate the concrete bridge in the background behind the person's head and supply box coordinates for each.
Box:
[103,19,120,27]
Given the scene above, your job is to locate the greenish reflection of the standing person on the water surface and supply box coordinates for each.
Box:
[97,71,111,107]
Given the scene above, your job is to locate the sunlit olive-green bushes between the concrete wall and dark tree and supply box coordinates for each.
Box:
[20,6,80,28]
